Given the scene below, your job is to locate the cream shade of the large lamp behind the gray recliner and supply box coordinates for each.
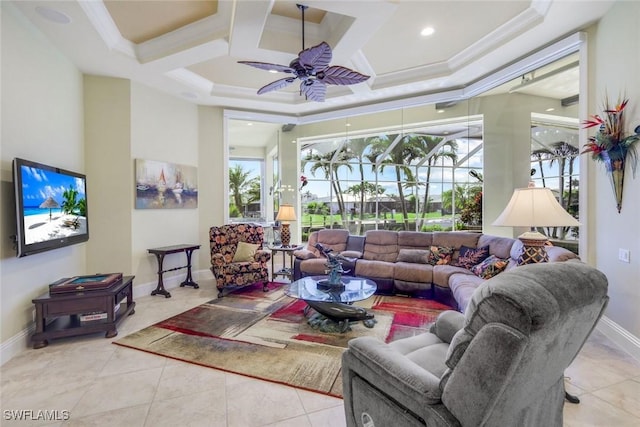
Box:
[492,187,581,227]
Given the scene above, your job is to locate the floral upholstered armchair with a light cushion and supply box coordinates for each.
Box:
[209,224,271,298]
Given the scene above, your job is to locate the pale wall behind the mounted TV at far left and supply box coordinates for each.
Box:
[0,2,85,348]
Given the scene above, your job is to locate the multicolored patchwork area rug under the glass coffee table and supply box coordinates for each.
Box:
[115,283,451,397]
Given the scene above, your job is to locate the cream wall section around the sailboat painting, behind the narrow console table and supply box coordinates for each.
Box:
[126,83,202,284]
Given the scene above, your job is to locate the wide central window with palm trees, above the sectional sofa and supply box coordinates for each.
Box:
[301,118,482,239]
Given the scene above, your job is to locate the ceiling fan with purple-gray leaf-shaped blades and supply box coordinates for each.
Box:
[238,4,369,102]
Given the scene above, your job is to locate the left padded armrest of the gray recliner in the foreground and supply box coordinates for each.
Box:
[343,337,442,404]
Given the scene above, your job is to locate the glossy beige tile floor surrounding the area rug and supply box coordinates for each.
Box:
[0,270,640,427]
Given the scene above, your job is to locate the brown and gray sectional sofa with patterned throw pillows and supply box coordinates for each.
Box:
[293,229,578,312]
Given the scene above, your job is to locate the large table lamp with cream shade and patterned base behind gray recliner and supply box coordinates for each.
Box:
[492,183,581,265]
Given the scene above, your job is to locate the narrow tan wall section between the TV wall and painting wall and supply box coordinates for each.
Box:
[84,76,134,275]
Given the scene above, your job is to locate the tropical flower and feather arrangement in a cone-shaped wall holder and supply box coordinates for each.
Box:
[582,98,640,213]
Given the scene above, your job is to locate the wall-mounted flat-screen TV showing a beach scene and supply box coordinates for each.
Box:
[13,158,89,257]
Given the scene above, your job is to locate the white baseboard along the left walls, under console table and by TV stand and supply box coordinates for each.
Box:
[0,270,212,366]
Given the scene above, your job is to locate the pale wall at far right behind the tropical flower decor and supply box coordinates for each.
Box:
[588,2,640,337]
